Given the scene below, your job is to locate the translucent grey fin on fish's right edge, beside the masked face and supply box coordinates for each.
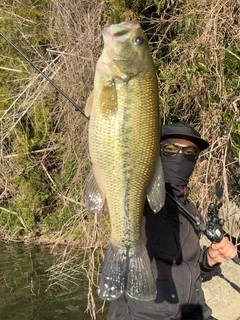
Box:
[147,155,166,213]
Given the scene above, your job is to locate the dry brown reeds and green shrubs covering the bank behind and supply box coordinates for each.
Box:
[0,0,240,316]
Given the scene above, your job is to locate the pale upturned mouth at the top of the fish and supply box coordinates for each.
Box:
[103,21,140,43]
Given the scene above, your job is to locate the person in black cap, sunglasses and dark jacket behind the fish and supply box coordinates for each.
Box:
[107,122,237,320]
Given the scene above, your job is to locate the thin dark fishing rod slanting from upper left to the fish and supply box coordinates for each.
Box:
[0,32,89,120]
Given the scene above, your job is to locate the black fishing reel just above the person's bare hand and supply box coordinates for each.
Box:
[204,203,225,242]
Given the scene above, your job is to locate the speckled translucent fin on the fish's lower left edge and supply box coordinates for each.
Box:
[84,168,105,213]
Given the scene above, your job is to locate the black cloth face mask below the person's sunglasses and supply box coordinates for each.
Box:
[161,152,196,186]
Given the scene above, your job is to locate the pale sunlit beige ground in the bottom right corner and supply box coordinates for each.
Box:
[203,239,240,320]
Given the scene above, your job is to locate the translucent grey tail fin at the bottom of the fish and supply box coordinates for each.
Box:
[98,243,157,301]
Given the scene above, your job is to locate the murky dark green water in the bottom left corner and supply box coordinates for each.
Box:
[0,243,106,320]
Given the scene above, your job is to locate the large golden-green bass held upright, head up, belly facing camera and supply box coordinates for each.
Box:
[85,21,165,301]
